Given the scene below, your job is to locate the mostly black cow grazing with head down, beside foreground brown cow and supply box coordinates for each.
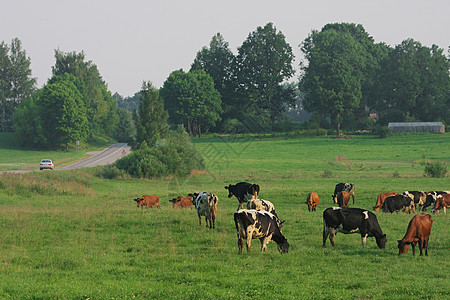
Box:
[322,207,387,249]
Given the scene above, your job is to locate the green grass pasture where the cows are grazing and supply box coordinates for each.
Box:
[0,134,450,299]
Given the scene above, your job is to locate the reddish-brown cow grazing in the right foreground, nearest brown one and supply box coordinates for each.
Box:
[398,214,433,256]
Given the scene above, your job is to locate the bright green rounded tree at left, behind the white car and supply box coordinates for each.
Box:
[39,74,90,146]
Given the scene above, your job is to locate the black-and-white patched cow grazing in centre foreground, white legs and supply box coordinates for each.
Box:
[234,209,289,254]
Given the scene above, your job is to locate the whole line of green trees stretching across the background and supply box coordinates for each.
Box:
[0,23,450,147]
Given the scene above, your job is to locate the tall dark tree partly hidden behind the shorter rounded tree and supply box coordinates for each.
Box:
[191,33,240,118]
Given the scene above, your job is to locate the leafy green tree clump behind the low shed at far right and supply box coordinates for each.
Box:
[374,39,450,122]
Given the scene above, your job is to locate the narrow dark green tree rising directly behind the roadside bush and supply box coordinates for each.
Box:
[136,82,168,145]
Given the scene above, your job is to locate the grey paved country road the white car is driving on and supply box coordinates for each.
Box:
[0,143,131,173]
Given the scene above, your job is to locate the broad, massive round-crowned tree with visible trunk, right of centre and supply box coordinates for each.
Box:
[299,29,366,135]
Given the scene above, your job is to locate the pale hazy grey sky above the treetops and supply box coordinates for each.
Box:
[0,0,450,97]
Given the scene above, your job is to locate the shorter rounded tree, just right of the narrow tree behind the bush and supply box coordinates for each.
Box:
[160,69,223,137]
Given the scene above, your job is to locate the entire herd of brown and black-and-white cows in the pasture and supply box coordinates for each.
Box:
[134,182,450,255]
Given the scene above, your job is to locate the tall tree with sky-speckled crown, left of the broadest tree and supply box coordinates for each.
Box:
[237,23,294,123]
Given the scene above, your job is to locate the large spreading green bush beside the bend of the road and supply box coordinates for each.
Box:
[115,127,205,178]
